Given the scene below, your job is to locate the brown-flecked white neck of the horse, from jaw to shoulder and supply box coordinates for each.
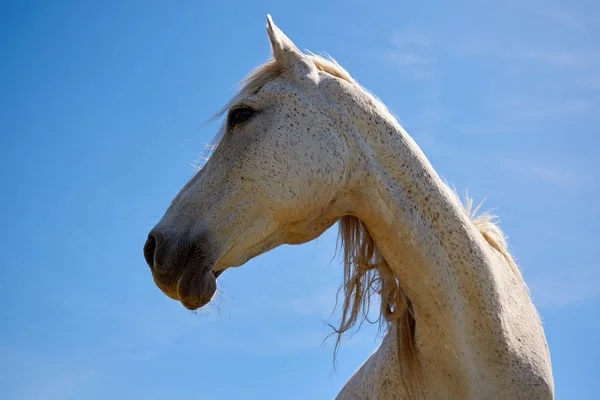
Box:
[344,96,549,392]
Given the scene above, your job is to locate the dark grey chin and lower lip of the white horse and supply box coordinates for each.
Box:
[177,268,218,310]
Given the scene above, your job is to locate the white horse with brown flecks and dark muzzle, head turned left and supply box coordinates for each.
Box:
[144,17,554,400]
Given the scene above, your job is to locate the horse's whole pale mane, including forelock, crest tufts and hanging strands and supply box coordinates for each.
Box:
[212,53,522,390]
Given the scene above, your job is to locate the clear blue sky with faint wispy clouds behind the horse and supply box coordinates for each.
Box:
[0,0,600,399]
